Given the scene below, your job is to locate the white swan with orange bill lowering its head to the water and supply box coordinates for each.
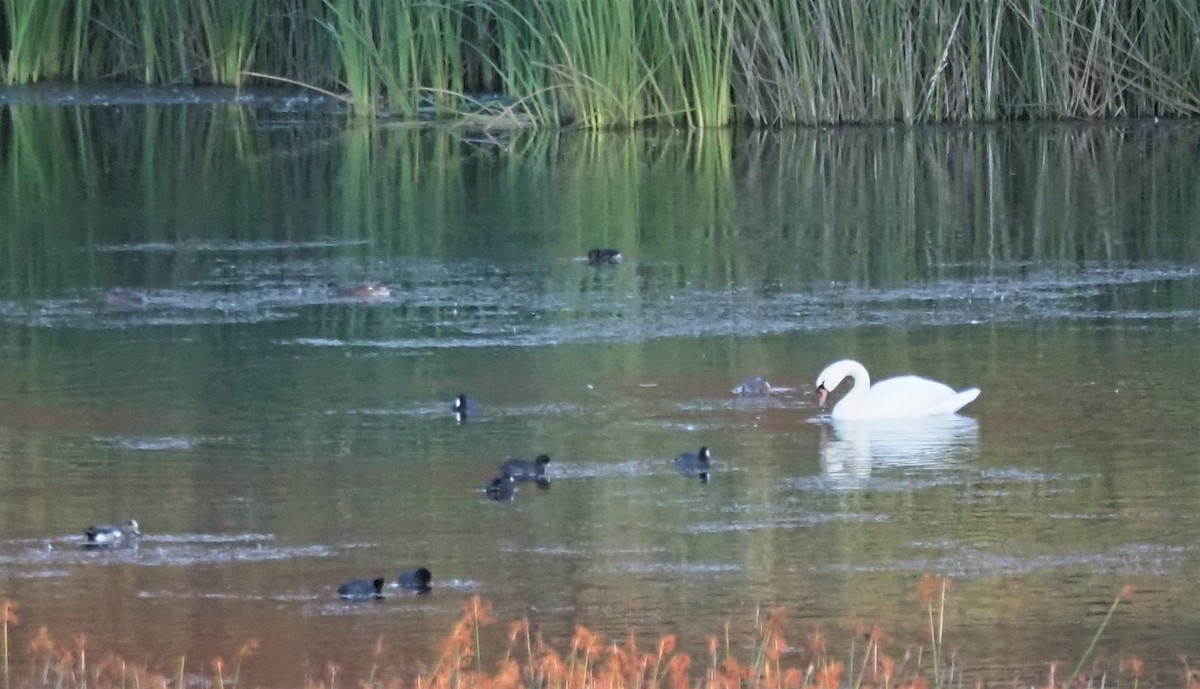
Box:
[817,359,979,419]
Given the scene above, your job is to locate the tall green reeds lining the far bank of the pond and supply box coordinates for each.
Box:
[0,0,1200,128]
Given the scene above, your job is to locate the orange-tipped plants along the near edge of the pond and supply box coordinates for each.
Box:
[0,576,1147,689]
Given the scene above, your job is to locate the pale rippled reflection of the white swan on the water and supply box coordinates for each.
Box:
[820,414,979,481]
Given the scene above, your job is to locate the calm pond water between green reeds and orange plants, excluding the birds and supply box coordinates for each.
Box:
[0,88,1200,687]
